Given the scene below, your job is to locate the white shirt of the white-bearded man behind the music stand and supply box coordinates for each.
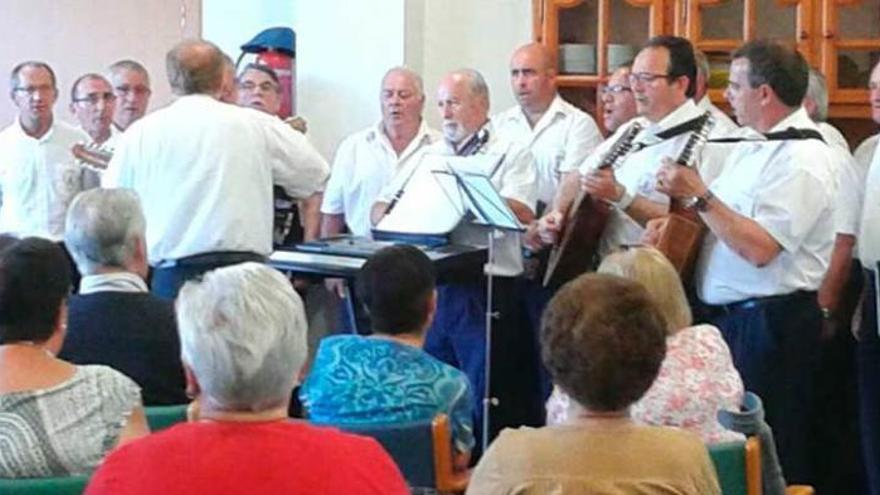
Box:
[379,123,537,277]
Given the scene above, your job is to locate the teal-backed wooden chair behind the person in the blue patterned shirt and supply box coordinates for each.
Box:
[328,414,470,493]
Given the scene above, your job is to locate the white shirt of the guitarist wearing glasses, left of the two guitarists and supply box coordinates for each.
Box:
[579,100,720,256]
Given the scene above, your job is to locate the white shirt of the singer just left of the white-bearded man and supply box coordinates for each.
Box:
[321,121,440,236]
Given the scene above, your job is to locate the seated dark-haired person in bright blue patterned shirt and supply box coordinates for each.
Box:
[300,245,474,467]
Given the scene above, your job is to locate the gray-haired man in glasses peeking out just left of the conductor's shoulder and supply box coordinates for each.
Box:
[107,60,152,132]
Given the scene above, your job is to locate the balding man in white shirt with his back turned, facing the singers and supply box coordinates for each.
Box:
[105,41,328,298]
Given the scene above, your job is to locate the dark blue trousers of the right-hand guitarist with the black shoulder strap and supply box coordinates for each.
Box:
[708,292,822,484]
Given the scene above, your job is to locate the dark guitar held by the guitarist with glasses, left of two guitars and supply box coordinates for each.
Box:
[544,122,642,287]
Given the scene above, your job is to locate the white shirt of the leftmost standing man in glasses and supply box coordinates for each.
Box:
[0,118,94,241]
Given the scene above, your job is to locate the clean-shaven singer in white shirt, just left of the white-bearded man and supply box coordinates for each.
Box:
[321,67,438,237]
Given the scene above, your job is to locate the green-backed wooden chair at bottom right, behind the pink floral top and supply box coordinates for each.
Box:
[709,437,814,495]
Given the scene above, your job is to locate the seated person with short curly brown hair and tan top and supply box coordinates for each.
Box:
[468,274,720,495]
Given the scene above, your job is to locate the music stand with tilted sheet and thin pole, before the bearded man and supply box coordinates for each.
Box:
[432,167,526,452]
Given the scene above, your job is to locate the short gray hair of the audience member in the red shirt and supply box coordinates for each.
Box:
[176,263,308,412]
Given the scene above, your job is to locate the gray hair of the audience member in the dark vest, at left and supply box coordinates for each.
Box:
[64,189,146,275]
